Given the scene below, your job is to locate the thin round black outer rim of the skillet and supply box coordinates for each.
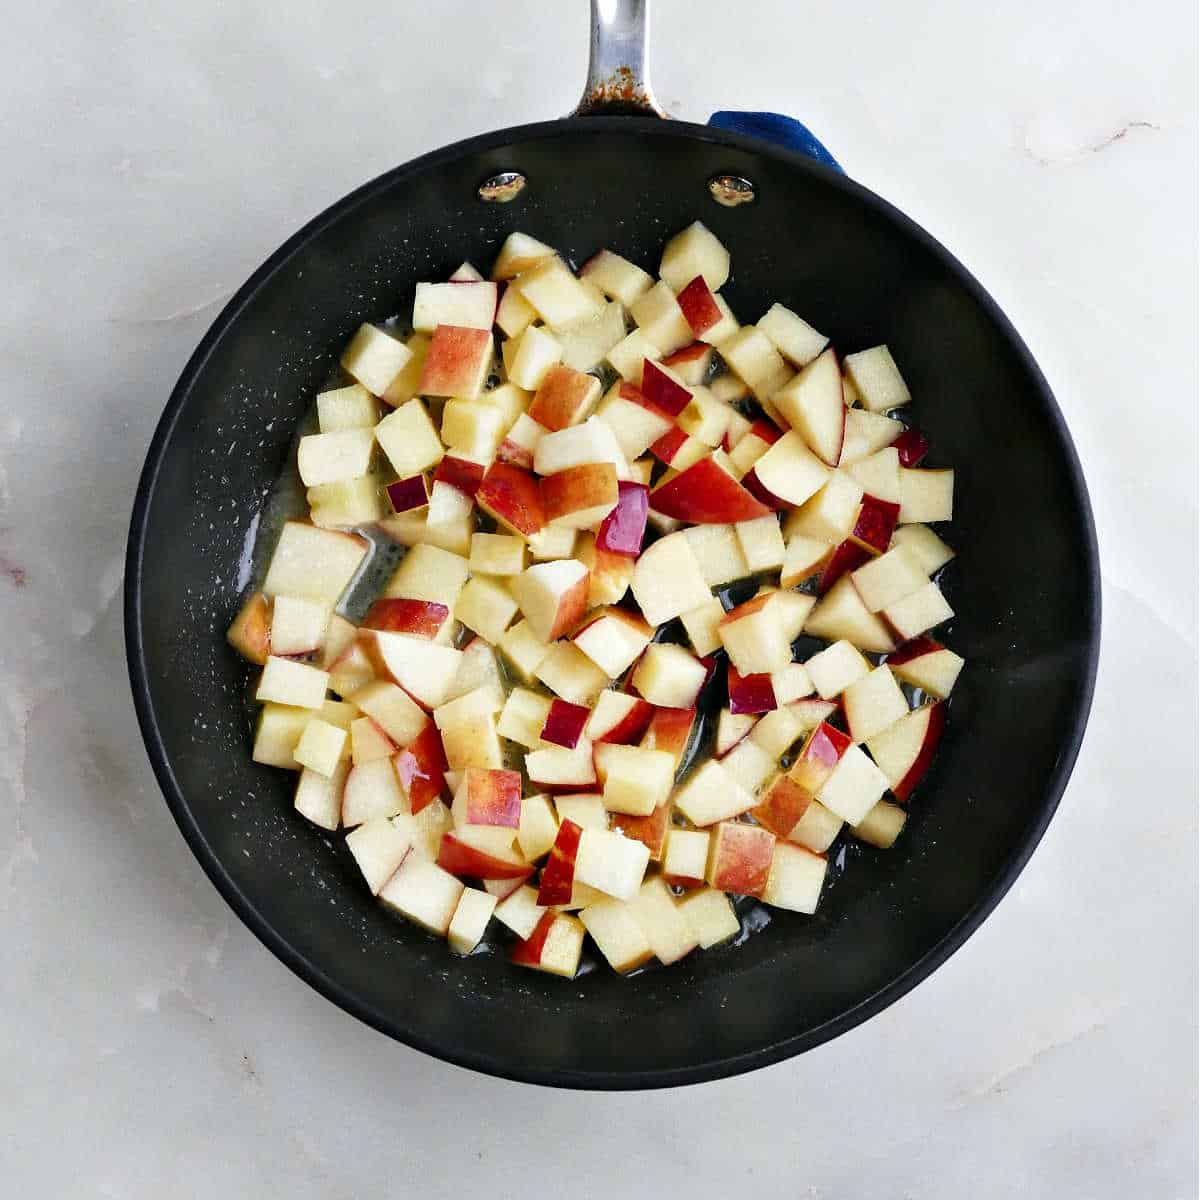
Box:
[124,116,1102,1091]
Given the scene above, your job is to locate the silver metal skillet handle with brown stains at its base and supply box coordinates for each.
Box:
[570,0,667,118]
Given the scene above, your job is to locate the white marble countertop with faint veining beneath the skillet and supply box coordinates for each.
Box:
[0,0,1198,1200]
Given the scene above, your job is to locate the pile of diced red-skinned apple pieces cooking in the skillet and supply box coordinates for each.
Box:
[229,222,964,977]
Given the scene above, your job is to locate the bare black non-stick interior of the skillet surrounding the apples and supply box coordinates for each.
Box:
[126,118,1099,1087]
